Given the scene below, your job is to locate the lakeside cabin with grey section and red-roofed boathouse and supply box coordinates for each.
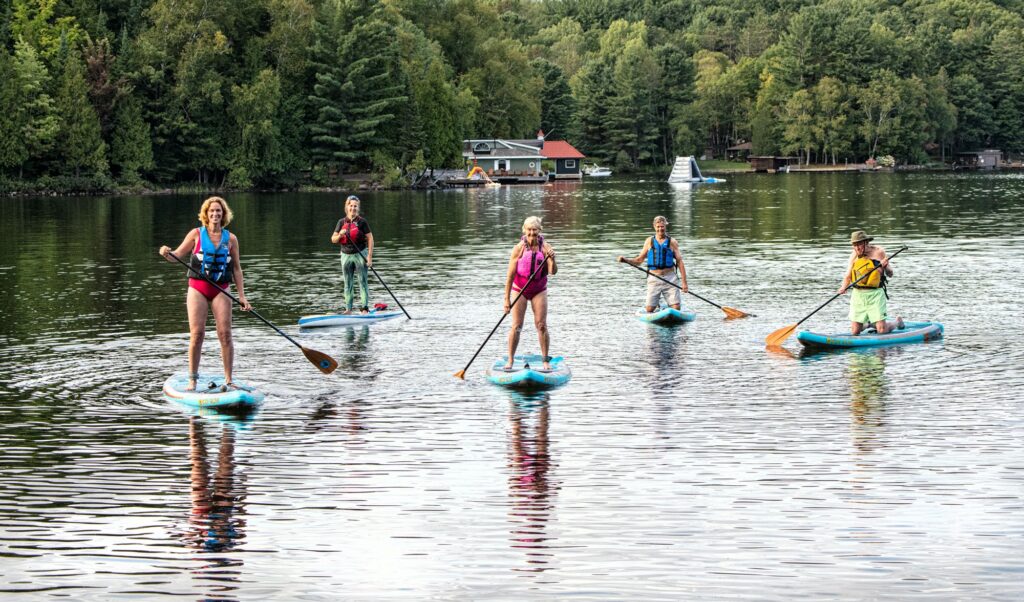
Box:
[462,131,585,184]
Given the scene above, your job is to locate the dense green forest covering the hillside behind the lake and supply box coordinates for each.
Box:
[0,0,1024,190]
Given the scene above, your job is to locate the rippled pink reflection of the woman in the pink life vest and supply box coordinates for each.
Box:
[509,393,552,570]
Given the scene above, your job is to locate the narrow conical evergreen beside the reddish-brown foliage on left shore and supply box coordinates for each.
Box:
[56,51,106,177]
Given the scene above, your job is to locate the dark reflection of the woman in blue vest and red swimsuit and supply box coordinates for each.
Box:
[184,417,246,552]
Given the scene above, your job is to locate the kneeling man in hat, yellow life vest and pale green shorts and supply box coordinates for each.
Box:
[839,230,903,335]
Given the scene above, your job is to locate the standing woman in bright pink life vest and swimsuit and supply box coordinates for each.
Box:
[505,216,558,370]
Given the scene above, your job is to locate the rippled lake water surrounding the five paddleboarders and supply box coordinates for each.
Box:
[0,173,1024,600]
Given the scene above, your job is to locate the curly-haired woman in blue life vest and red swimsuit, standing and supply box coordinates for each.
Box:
[160,197,252,391]
